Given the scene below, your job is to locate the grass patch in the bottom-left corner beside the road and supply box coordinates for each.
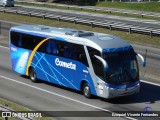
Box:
[0,98,55,120]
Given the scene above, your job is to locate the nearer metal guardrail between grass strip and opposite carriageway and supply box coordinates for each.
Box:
[0,7,160,37]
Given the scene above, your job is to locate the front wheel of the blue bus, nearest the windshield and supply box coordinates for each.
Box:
[83,83,91,98]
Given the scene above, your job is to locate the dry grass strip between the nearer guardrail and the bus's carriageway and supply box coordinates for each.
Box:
[0,13,160,46]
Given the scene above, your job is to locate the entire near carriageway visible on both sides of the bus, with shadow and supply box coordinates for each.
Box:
[0,2,160,120]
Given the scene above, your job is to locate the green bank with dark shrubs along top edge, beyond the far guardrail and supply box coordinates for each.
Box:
[35,0,160,12]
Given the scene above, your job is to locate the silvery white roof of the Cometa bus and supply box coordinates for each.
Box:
[11,25,131,51]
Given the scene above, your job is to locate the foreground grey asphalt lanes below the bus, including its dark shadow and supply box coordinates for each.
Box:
[0,43,160,120]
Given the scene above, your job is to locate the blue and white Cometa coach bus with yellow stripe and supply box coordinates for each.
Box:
[10,25,145,98]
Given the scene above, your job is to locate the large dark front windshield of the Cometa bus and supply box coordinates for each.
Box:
[103,51,139,84]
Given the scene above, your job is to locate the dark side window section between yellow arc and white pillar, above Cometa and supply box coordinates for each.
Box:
[38,39,88,66]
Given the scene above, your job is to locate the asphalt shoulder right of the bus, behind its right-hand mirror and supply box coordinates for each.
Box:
[132,44,160,82]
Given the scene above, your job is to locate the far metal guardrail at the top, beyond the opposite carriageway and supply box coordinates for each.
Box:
[16,0,160,18]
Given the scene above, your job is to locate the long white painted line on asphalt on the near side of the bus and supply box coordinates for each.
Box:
[0,75,137,120]
